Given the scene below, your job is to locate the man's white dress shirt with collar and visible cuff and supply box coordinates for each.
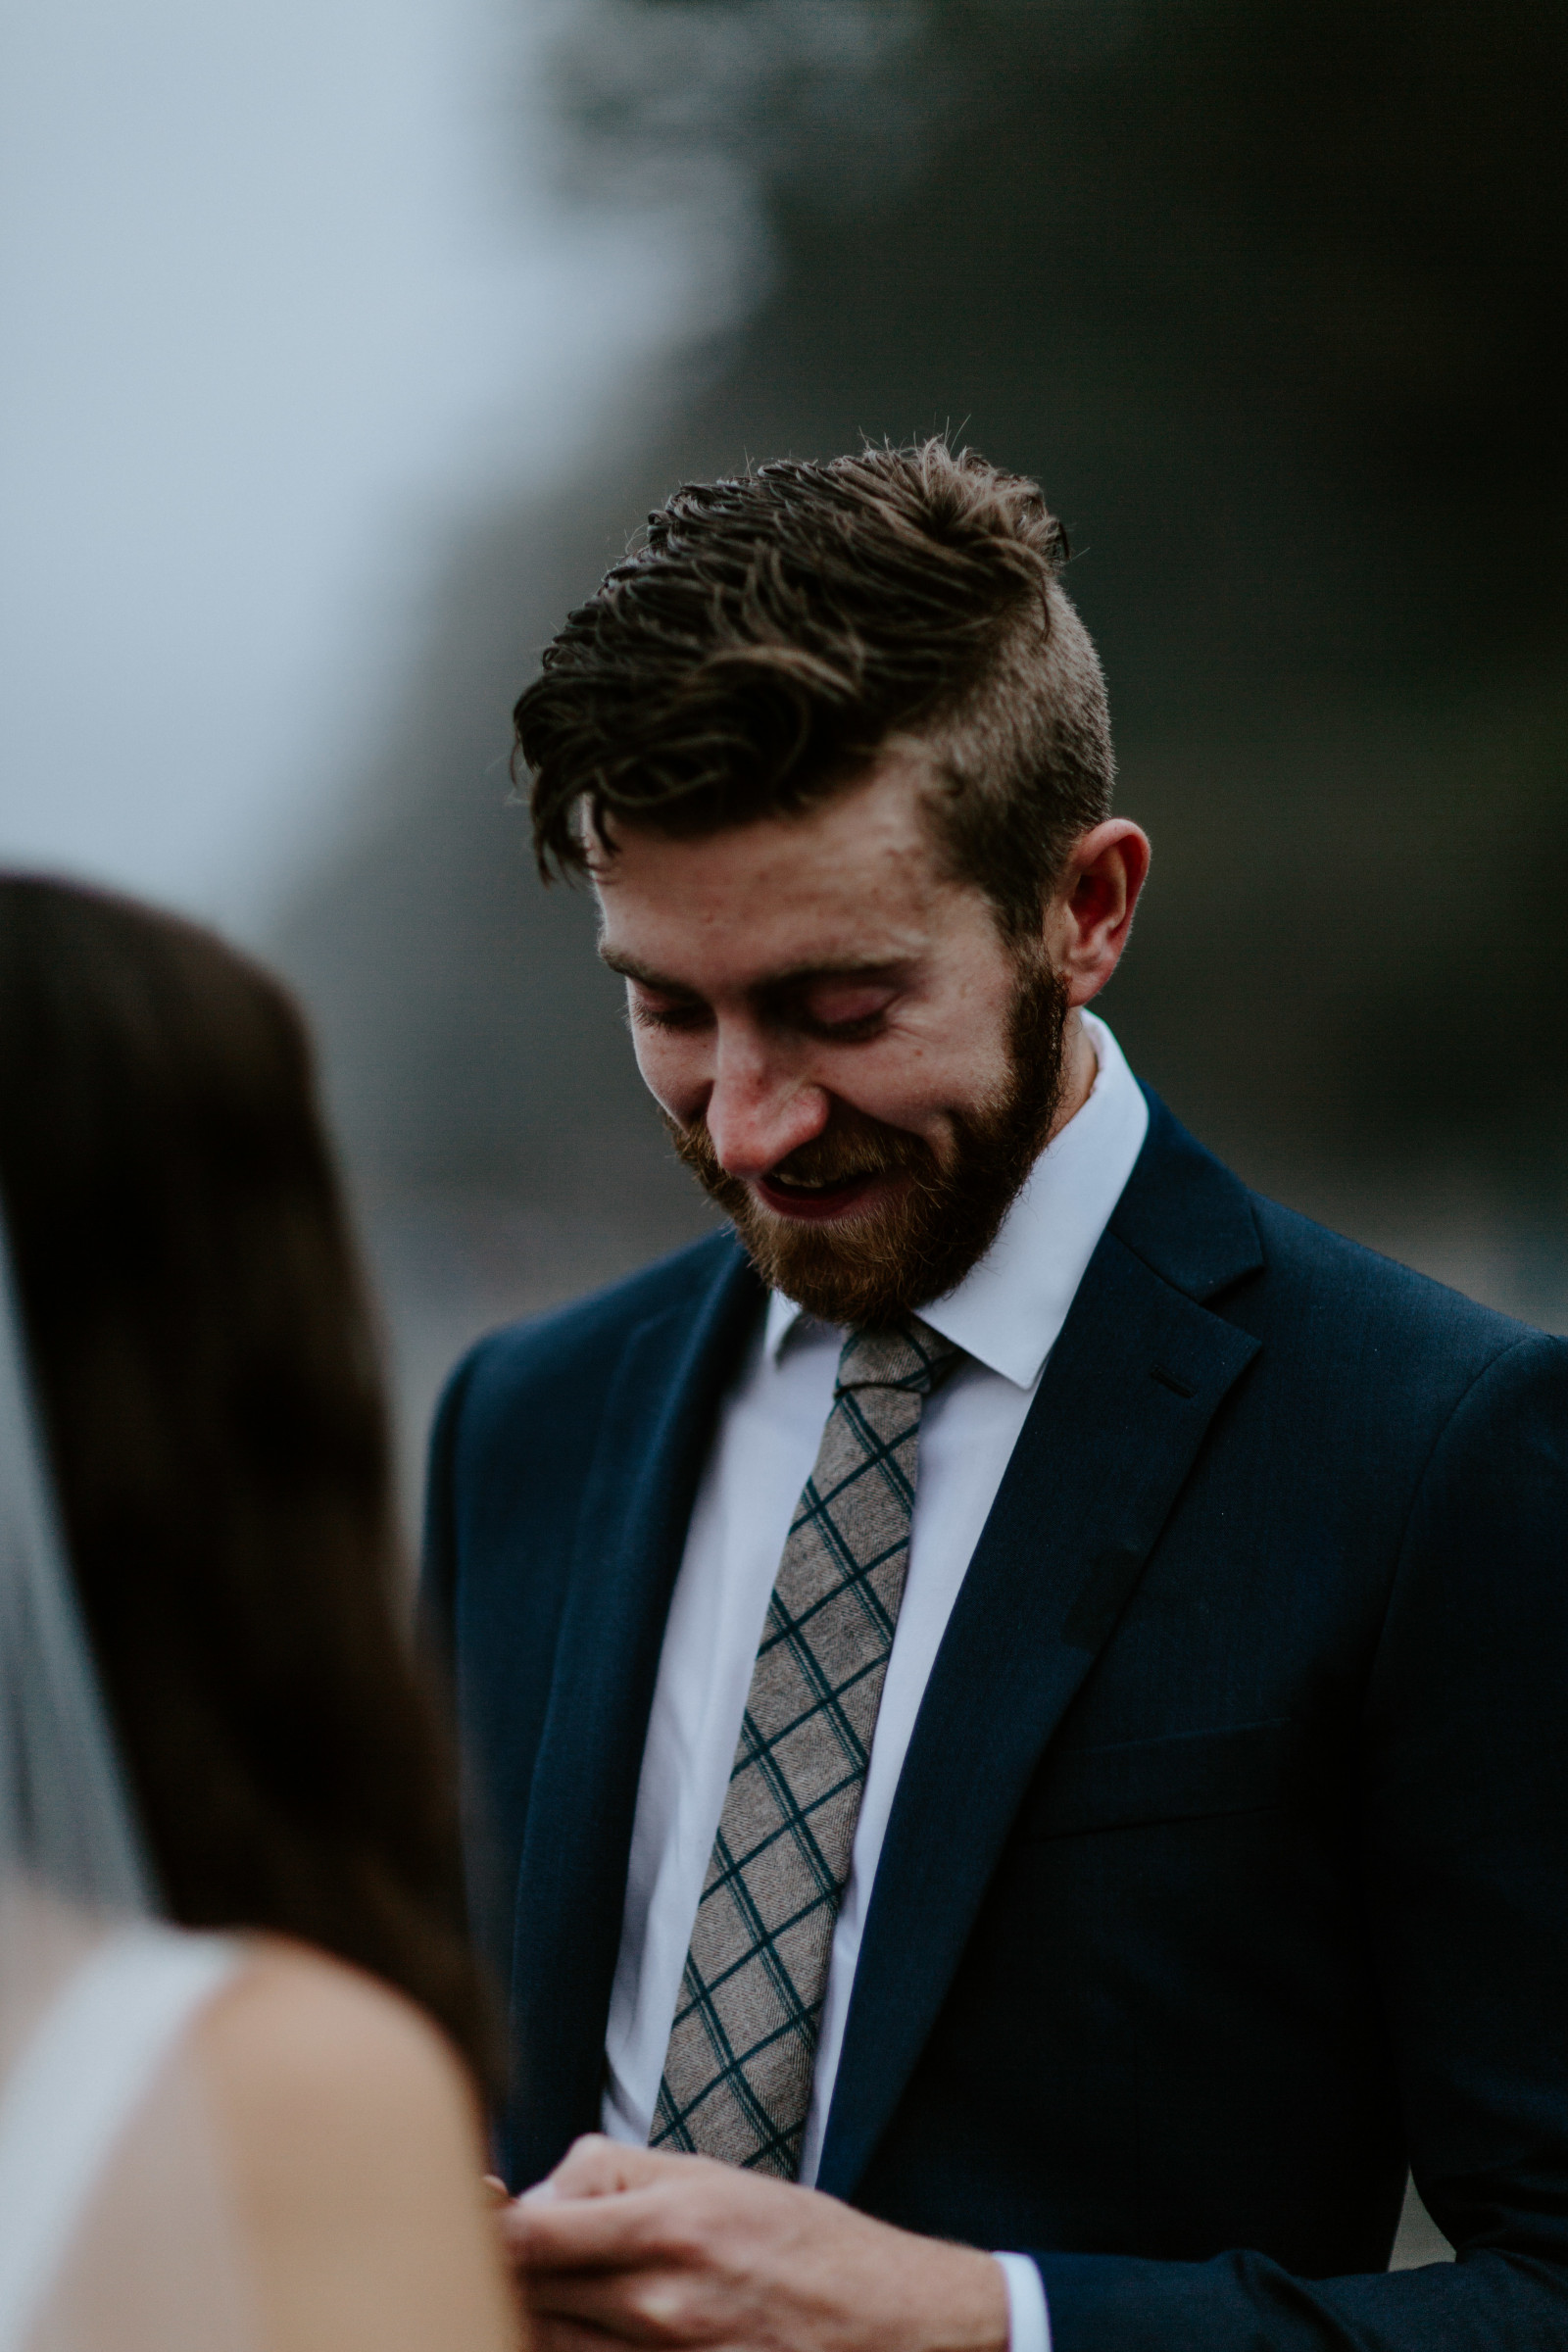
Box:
[602,1013,1150,2352]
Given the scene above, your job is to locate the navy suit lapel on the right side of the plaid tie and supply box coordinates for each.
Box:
[818,1103,1260,2197]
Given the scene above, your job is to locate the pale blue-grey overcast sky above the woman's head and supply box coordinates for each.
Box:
[0,0,723,934]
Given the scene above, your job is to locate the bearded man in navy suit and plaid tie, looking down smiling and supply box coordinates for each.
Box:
[428,442,1568,2352]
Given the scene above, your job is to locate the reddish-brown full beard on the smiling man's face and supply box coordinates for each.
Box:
[665,962,1067,1329]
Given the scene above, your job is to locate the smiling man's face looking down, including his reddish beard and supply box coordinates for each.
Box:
[595,755,1065,1324]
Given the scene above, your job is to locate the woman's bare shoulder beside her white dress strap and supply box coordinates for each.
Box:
[195,1940,514,2352]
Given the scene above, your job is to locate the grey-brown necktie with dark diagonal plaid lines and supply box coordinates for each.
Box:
[651,1317,959,2180]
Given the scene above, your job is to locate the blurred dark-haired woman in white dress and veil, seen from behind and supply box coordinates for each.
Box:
[0,877,514,2352]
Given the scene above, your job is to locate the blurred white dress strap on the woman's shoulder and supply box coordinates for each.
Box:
[0,1924,244,2352]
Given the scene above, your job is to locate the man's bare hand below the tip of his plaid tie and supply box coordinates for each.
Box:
[501,2135,1008,2352]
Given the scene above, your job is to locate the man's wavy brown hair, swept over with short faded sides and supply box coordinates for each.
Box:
[514,440,1114,939]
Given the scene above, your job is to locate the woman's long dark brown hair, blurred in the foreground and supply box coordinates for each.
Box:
[0,875,489,2072]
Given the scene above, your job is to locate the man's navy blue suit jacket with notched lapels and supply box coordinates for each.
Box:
[428,1103,1568,2352]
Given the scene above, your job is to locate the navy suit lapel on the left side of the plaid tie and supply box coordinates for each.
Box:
[506,1249,761,2185]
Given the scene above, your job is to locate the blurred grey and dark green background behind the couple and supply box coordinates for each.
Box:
[0,0,1568,1524]
